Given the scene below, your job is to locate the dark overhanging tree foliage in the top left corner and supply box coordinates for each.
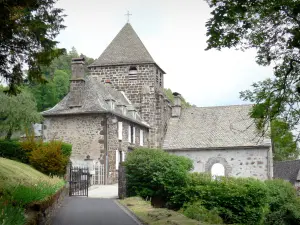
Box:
[0,0,65,94]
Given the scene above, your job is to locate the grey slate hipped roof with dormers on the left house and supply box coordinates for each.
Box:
[42,75,149,127]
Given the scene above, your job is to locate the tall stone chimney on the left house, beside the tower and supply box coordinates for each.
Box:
[67,58,85,108]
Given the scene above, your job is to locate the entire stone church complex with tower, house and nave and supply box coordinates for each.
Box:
[42,23,273,184]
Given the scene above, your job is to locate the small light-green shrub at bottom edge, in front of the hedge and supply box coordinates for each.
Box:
[183,201,223,224]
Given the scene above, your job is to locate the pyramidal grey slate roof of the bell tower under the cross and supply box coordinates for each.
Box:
[90,23,155,66]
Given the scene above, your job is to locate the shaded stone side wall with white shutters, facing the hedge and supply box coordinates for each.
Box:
[108,116,149,184]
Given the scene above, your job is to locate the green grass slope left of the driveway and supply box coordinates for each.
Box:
[0,158,64,225]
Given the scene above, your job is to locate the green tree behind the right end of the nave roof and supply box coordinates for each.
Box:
[271,120,300,161]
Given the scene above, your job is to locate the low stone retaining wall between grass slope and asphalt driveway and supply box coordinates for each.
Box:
[25,187,69,225]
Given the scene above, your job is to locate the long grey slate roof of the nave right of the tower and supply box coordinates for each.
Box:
[163,105,270,150]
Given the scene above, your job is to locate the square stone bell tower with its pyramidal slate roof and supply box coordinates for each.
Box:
[89,23,171,148]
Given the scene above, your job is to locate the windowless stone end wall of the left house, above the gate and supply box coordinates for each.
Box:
[43,115,104,163]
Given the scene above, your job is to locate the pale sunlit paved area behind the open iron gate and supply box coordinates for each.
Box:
[89,184,118,198]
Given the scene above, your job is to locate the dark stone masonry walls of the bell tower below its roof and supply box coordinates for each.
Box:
[90,64,170,147]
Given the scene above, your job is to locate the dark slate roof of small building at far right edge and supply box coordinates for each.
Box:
[273,159,300,184]
